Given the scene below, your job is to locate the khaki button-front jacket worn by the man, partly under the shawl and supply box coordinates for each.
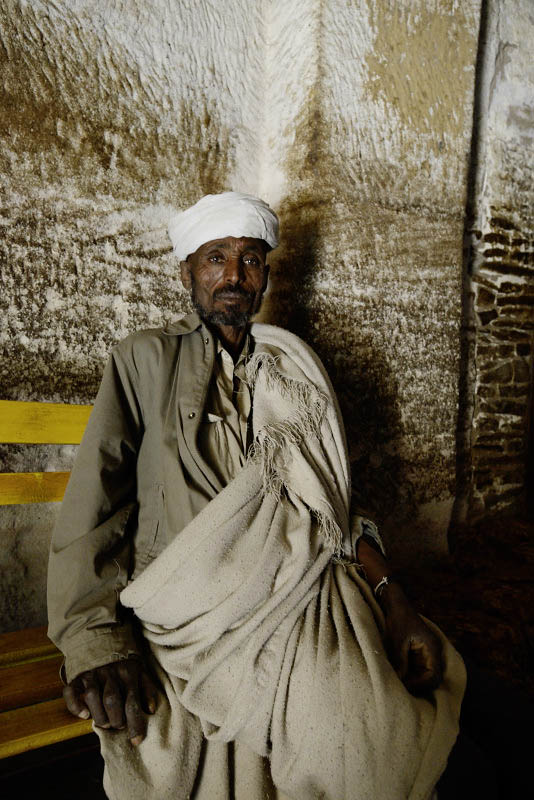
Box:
[48,314,230,681]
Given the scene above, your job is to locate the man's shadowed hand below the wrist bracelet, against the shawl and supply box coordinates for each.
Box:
[380,583,443,695]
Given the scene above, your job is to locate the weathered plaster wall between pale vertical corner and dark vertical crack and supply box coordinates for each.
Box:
[266,0,480,558]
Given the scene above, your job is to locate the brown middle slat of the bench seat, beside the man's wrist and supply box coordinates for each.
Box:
[0,653,63,708]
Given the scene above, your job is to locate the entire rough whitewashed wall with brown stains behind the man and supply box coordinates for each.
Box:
[0,0,534,629]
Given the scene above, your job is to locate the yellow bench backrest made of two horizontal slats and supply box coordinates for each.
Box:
[0,400,92,505]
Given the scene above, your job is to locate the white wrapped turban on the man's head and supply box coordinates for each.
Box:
[169,192,278,261]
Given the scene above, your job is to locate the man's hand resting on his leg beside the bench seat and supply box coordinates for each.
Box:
[63,658,157,745]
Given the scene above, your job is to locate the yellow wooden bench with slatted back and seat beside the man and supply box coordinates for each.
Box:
[0,400,91,758]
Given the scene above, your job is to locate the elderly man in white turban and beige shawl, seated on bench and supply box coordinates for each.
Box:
[49,192,464,800]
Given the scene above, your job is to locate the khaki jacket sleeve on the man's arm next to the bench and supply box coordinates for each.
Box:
[48,346,143,681]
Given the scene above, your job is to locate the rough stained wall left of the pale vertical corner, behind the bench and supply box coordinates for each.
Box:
[0,0,264,628]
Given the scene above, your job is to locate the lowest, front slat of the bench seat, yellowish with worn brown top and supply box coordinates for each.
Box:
[0,697,92,758]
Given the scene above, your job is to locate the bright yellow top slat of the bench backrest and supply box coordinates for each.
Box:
[0,400,92,444]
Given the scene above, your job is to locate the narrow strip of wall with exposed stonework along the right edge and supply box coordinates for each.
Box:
[462,0,534,521]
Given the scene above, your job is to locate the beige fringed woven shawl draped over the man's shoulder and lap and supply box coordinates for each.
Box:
[98,325,465,800]
